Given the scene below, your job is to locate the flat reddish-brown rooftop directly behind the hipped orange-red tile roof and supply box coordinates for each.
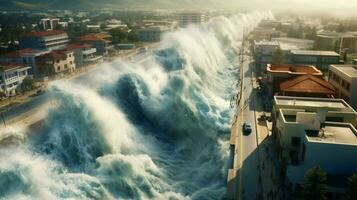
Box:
[267,64,322,76]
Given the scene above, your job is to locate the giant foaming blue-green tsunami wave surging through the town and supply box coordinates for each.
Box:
[0,13,271,199]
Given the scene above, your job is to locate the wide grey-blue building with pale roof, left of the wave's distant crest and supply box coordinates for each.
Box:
[138,26,170,42]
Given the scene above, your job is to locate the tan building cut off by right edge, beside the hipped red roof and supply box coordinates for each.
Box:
[328,65,357,109]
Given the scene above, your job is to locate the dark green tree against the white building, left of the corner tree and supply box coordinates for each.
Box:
[302,166,327,200]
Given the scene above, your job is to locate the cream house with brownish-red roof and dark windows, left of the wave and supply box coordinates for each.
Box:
[35,50,76,78]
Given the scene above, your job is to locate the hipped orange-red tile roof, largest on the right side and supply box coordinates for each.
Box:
[280,75,335,95]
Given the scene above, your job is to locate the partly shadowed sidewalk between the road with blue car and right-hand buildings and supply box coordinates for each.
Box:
[254,76,284,200]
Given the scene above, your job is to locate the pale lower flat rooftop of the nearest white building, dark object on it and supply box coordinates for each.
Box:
[305,123,357,145]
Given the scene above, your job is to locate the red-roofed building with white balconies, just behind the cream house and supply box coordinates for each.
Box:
[67,44,103,68]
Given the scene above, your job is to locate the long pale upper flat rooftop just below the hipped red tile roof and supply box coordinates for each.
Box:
[274,96,355,112]
